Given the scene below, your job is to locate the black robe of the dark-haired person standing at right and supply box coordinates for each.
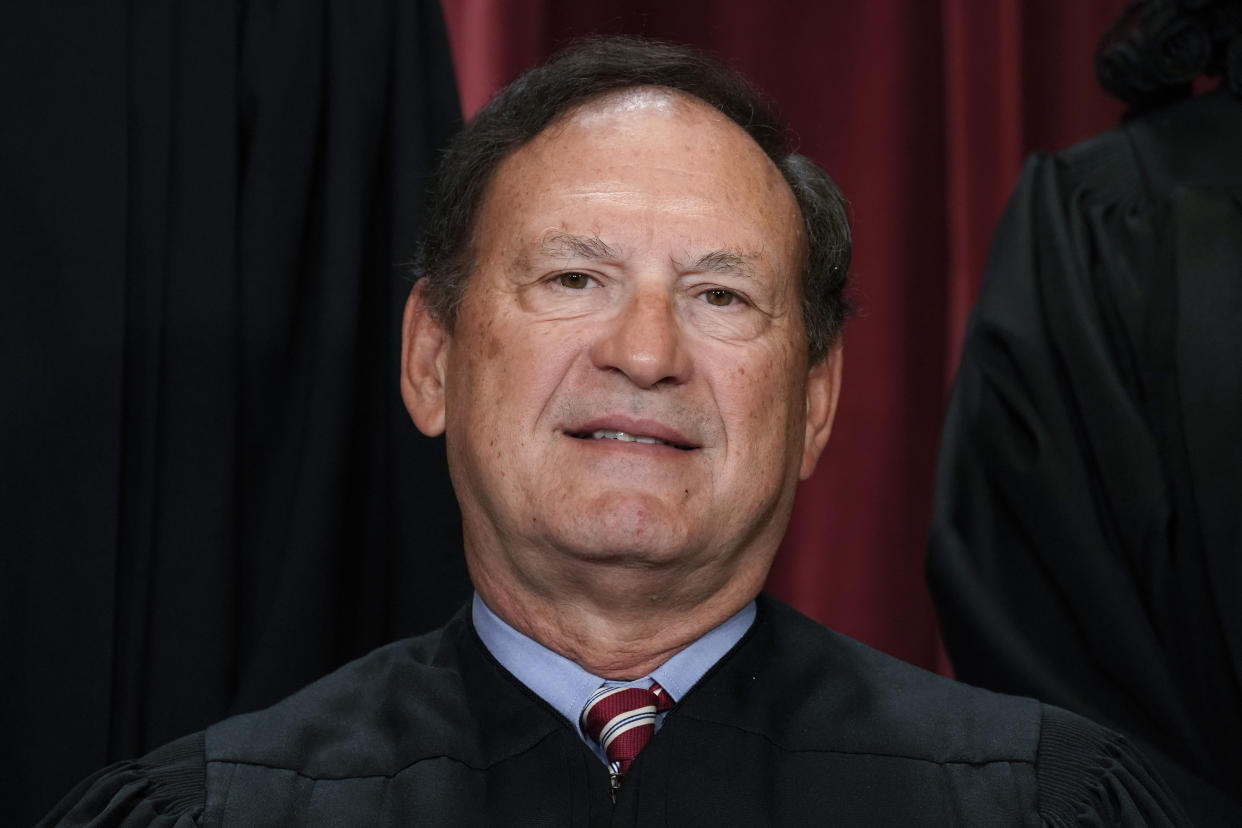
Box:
[928,92,1242,826]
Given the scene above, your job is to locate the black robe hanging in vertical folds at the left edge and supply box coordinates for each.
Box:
[0,0,468,824]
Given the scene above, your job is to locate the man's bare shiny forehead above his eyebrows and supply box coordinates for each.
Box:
[476,87,801,258]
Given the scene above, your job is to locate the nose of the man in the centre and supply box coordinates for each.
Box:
[591,286,692,389]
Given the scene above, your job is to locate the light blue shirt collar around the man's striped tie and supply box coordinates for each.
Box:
[471,592,755,765]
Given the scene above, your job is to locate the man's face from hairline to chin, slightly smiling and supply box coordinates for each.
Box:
[407,89,837,608]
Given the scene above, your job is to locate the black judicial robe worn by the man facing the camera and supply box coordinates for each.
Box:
[38,597,1184,828]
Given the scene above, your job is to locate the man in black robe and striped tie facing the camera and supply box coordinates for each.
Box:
[50,40,1180,826]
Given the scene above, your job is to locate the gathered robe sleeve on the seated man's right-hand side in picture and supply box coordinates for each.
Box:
[1036,705,1191,828]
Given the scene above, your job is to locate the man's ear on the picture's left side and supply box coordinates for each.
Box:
[401,281,448,437]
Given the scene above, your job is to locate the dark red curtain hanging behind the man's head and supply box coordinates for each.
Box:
[445,0,1124,670]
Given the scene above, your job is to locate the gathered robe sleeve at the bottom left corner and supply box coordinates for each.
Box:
[39,732,206,828]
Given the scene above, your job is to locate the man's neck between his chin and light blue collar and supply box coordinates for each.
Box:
[468,556,766,680]
